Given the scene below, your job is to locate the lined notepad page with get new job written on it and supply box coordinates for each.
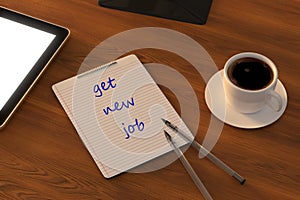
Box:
[52,55,193,178]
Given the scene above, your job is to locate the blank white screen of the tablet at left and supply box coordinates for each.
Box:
[0,17,55,110]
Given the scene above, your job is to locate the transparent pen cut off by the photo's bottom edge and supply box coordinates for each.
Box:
[164,131,213,200]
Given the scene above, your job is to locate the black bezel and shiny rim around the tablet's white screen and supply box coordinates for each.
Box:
[0,6,71,130]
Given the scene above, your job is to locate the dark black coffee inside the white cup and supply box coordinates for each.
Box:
[227,58,273,90]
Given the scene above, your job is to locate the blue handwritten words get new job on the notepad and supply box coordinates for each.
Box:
[94,77,145,139]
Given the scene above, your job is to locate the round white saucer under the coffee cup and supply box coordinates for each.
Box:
[205,70,287,129]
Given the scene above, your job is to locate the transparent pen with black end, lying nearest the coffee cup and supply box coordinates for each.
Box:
[162,119,246,185]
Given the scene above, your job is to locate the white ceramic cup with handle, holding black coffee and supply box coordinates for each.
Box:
[223,52,282,113]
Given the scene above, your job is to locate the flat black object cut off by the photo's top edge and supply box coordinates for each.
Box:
[98,0,213,24]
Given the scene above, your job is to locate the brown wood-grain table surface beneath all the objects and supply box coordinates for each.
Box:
[0,0,300,200]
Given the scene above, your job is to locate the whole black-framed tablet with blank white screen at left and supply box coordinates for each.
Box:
[0,7,70,128]
